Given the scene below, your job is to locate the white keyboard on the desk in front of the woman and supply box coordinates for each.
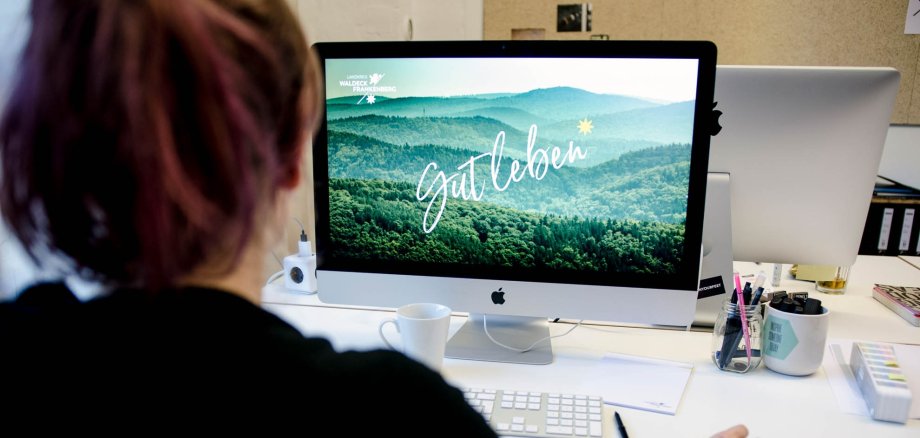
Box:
[463,388,605,438]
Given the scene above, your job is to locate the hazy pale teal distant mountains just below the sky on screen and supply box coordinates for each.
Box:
[328,87,693,167]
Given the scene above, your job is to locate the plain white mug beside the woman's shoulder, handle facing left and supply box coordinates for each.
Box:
[378,303,450,371]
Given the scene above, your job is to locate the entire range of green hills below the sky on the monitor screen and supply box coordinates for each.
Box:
[327,87,693,273]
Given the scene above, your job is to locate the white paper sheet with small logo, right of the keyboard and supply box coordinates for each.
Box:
[591,353,693,415]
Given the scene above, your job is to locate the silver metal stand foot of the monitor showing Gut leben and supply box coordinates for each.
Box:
[444,313,553,365]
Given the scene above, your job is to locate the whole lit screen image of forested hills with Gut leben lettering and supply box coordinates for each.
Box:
[325,58,698,281]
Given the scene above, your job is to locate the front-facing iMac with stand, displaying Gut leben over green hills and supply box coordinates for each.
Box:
[313,41,716,363]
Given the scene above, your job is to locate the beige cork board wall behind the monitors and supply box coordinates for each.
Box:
[483,0,920,125]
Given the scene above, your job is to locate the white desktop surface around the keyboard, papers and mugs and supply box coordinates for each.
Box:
[264,256,920,438]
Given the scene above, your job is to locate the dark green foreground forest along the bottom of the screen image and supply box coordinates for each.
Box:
[330,176,684,273]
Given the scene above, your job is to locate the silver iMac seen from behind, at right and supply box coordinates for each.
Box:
[696,65,900,324]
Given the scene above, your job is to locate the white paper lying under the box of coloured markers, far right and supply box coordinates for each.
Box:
[822,339,920,419]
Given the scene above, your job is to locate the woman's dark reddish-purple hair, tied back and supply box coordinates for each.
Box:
[0,0,320,288]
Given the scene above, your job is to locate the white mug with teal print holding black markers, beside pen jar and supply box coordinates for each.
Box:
[761,305,830,376]
